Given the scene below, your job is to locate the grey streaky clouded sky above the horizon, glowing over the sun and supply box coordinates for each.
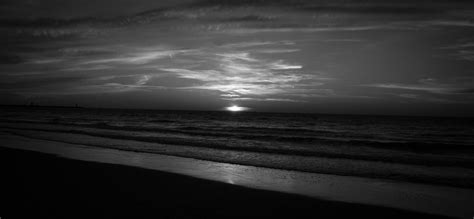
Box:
[0,0,474,116]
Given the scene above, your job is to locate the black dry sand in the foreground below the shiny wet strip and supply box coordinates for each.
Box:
[0,148,452,219]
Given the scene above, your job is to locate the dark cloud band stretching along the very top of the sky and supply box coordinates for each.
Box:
[0,0,474,28]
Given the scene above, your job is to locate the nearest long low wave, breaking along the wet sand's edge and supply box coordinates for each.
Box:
[4,127,474,188]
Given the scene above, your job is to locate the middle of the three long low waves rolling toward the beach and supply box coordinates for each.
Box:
[3,124,474,168]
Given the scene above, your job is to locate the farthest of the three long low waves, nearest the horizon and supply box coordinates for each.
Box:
[16,120,474,148]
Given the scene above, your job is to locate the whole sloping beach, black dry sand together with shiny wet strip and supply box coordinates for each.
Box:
[0,133,473,218]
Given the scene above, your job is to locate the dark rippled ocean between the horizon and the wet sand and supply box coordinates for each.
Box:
[0,107,474,188]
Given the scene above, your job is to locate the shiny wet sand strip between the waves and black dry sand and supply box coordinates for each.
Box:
[1,134,474,218]
